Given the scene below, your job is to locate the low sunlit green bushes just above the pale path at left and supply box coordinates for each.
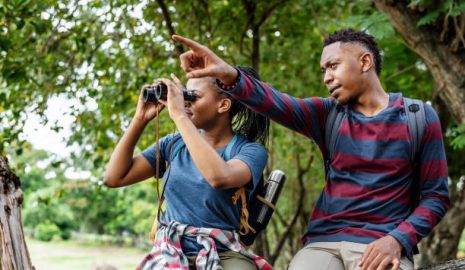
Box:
[12,149,156,243]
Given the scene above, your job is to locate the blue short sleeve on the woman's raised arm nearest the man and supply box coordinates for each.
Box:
[232,143,268,189]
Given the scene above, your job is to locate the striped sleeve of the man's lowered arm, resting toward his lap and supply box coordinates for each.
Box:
[389,104,450,254]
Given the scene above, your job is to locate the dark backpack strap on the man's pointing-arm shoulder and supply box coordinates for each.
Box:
[325,104,344,175]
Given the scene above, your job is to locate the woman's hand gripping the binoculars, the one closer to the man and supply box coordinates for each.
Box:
[158,74,187,121]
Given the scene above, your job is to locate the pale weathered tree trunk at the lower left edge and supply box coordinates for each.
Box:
[0,155,34,270]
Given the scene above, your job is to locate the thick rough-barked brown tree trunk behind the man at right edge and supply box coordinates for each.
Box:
[373,0,465,269]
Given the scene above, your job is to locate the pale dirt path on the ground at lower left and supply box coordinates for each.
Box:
[27,239,145,270]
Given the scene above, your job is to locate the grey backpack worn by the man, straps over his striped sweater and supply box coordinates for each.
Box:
[325,97,426,254]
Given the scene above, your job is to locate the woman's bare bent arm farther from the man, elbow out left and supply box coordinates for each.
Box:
[104,85,164,187]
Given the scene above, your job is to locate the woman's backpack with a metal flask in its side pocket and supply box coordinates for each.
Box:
[150,134,285,248]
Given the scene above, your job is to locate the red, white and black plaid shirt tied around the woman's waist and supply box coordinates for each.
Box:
[137,221,273,270]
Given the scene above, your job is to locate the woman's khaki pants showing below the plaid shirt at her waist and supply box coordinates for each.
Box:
[187,251,257,270]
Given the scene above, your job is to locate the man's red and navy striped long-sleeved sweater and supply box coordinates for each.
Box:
[228,70,449,259]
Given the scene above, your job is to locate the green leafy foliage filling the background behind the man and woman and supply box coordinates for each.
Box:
[0,0,465,265]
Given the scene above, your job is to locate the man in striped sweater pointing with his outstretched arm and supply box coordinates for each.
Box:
[173,29,449,270]
